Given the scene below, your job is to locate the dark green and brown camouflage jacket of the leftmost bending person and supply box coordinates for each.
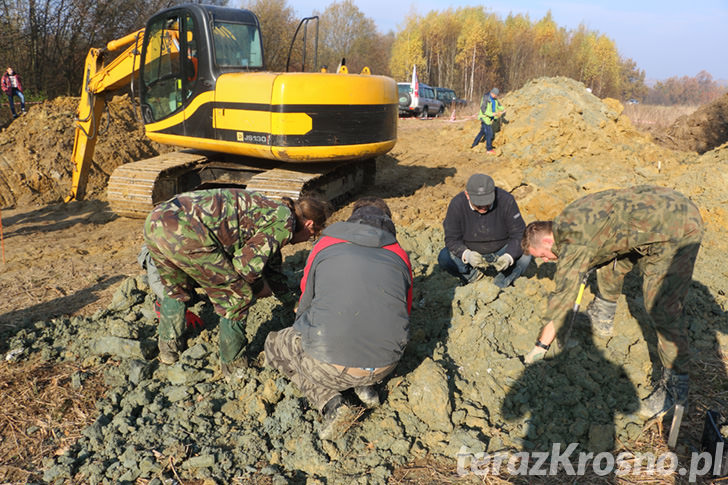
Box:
[151,189,295,284]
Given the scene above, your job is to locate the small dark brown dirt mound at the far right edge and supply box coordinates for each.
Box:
[660,90,728,154]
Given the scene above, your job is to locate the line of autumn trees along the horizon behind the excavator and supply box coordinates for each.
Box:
[0,0,725,104]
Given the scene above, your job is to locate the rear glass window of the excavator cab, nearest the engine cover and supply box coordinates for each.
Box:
[213,21,263,69]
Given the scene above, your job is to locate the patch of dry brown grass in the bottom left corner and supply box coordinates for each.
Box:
[0,354,105,483]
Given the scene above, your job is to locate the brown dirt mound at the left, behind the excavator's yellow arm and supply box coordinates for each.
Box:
[0,95,162,207]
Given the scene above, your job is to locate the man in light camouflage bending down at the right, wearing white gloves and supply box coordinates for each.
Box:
[522,186,703,417]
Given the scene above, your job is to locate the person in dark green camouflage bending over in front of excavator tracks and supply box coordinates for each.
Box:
[144,189,328,380]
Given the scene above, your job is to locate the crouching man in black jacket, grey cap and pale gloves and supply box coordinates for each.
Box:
[437,173,531,288]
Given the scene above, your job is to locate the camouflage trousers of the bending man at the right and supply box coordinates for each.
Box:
[597,204,703,374]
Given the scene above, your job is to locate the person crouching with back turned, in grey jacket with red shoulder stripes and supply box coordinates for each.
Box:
[265,197,412,439]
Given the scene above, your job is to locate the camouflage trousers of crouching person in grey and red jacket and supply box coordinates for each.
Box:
[265,327,395,411]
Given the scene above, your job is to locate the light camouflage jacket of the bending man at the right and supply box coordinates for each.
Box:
[544,186,702,334]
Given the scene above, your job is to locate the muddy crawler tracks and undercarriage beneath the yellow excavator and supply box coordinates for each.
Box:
[107,151,376,218]
